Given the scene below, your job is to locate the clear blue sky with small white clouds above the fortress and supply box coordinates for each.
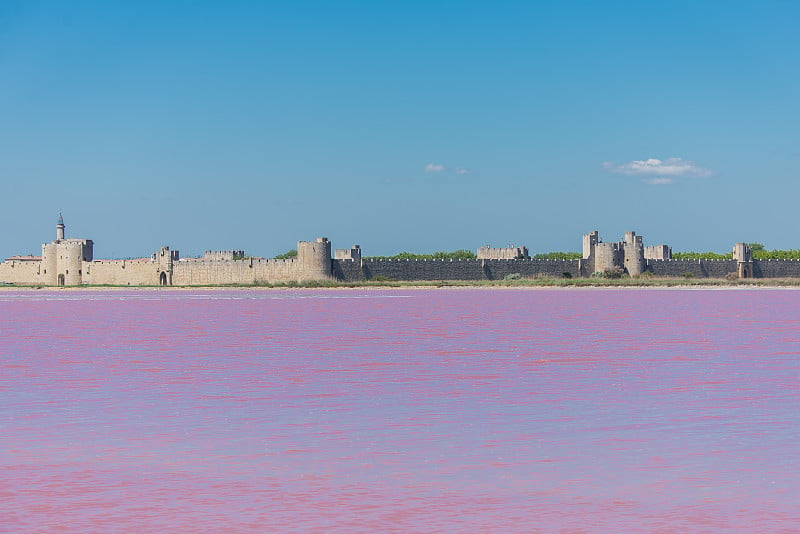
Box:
[0,0,800,257]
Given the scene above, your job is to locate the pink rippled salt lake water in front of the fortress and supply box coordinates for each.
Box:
[0,289,800,532]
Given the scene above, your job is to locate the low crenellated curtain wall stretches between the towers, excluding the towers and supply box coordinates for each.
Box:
[10,253,800,286]
